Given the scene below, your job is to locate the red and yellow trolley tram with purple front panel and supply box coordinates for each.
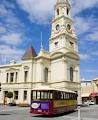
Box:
[30,88,77,115]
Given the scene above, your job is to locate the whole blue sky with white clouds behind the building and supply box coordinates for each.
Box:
[0,0,98,80]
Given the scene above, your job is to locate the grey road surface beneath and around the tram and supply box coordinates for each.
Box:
[0,105,98,120]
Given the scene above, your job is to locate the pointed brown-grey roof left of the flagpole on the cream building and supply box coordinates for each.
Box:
[22,46,37,60]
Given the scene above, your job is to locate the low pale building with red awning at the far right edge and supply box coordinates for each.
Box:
[81,78,98,104]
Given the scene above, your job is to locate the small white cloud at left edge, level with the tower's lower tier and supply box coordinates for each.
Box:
[0,33,22,46]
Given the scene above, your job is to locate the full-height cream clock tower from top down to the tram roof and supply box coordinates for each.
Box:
[49,0,81,102]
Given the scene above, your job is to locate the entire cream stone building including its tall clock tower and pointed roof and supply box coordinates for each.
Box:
[0,0,80,104]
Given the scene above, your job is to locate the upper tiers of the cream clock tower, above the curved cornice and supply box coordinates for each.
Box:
[49,0,78,54]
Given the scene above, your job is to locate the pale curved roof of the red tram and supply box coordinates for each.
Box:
[32,86,76,93]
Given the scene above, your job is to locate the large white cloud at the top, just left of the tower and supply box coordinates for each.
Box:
[17,0,55,24]
